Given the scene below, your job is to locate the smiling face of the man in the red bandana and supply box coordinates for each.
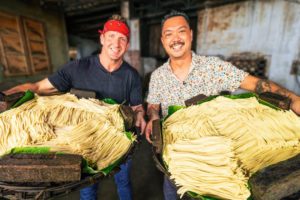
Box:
[100,31,129,61]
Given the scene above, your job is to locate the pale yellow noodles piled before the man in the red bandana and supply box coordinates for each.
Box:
[0,94,134,169]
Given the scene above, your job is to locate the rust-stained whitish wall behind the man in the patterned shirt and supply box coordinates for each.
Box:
[197,0,300,94]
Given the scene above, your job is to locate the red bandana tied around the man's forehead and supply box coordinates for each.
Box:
[98,19,130,40]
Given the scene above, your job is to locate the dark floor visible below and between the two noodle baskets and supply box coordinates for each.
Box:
[55,137,164,200]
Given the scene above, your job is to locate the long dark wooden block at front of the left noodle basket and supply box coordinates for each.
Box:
[0,154,82,183]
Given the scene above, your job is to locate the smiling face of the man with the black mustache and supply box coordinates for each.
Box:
[161,16,193,59]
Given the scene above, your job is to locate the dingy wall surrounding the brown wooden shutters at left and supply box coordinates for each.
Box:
[0,0,68,89]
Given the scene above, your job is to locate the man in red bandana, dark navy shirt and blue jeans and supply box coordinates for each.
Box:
[4,15,146,200]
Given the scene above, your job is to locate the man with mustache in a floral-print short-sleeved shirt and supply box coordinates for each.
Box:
[145,11,300,200]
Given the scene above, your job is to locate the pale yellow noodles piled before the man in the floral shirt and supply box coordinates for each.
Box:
[163,96,300,199]
